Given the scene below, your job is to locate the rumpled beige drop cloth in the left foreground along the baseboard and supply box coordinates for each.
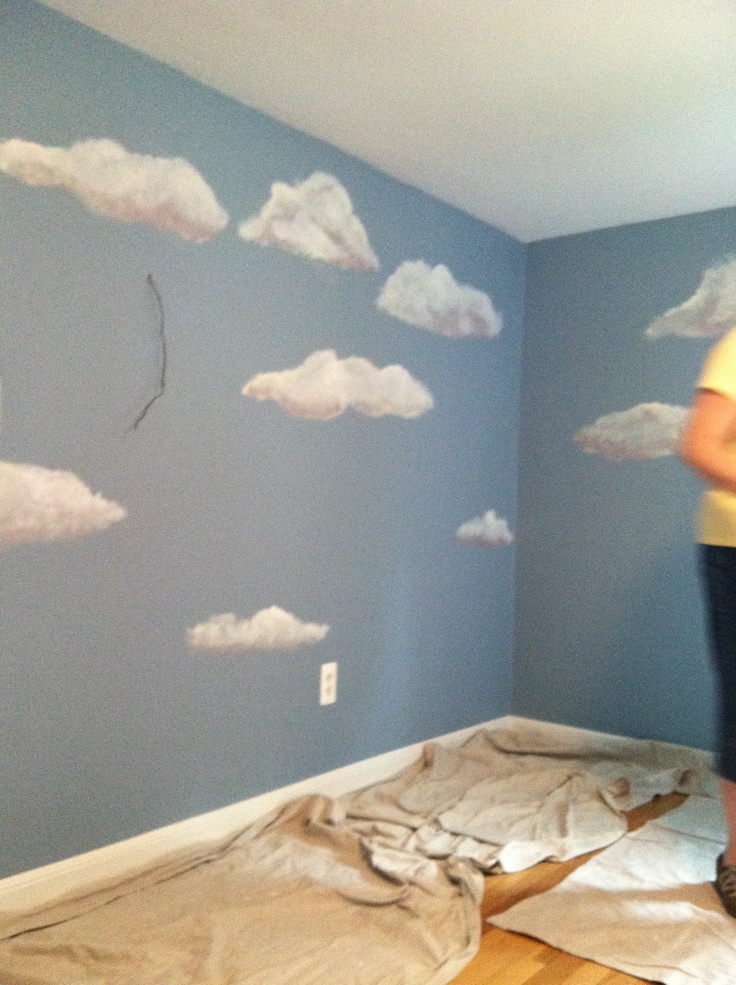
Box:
[0,797,482,985]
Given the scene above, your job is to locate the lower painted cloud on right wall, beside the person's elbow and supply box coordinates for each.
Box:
[574,403,690,462]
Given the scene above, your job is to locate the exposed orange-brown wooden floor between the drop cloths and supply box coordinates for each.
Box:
[453,794,685,985]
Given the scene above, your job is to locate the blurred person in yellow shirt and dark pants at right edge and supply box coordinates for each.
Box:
[680,329,736,917]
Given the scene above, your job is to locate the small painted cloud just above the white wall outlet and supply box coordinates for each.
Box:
[187,605,330,650]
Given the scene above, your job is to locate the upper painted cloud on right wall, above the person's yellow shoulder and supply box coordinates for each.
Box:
[644,260,736,339]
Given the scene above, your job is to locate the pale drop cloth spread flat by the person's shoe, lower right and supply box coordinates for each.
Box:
[490,797,736,985]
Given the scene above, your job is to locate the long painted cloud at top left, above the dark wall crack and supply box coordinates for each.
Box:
[0,140,228,243]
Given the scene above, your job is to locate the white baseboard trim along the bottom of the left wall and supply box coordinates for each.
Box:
[0,715,514,912]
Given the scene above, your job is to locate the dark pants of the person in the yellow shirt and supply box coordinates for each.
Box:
[700,544,736,782]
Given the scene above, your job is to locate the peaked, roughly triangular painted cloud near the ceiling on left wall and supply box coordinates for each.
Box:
[238,171,378,270]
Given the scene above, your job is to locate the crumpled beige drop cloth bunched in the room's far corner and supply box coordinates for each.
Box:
[338,720,717,872]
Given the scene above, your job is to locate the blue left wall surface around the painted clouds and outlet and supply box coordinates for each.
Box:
[0,0,524,876]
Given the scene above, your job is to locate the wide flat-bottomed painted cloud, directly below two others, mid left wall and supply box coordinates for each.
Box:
[243,349,434,421]
